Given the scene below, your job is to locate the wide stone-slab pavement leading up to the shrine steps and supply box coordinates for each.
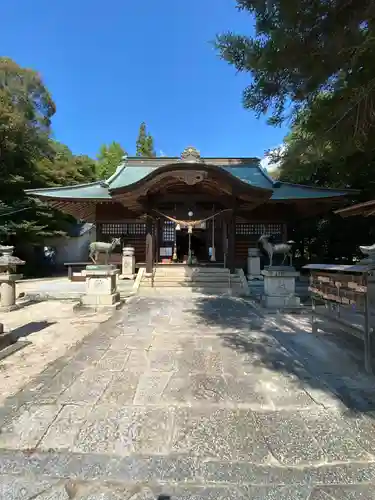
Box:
[0,295,375,500]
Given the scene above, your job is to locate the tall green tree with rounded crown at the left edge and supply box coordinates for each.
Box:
[0,57,55,242]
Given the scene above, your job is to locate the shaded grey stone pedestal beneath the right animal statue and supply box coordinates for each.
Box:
[262,267,301,309]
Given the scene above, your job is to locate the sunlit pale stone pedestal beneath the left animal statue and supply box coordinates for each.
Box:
[81,265,120,308]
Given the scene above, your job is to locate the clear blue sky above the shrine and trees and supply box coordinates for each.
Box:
[1,0,286,157]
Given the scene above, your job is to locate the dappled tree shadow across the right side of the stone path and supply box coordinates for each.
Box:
[191,297,375,418]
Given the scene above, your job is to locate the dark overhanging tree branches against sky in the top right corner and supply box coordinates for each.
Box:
[216,0,375,155]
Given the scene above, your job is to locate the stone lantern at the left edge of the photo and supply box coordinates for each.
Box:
[0,246,25,311]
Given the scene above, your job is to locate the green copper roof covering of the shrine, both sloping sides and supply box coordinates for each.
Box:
[26,158,348,201]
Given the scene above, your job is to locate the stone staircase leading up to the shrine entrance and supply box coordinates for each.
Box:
[136,264,248,295]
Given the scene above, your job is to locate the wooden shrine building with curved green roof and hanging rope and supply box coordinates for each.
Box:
[26,147,349,272]
